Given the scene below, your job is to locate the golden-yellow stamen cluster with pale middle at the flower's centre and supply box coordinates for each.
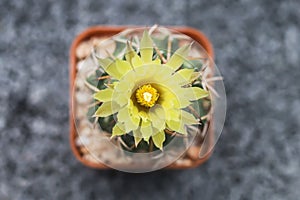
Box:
[135,84,159,108]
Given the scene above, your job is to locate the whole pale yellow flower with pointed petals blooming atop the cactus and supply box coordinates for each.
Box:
[94,31,208,150]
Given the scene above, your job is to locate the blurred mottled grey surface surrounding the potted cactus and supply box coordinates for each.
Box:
[0,0,300,200]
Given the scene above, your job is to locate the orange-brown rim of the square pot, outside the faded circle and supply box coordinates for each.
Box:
[69,26,214,169]
